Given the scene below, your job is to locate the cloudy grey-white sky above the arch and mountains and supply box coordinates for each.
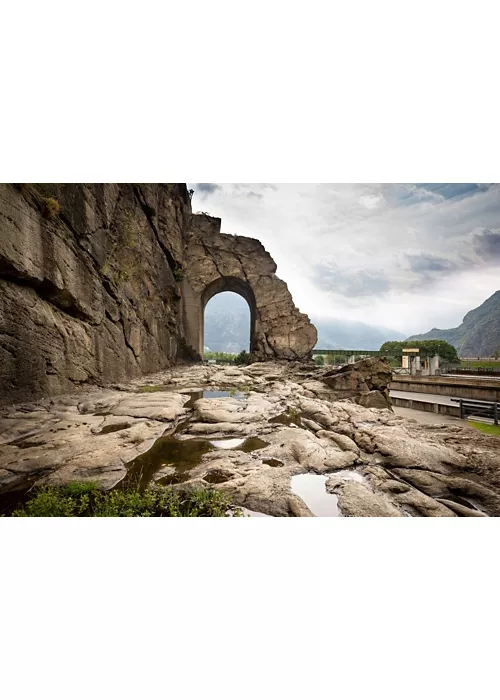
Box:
[189,183,500,335]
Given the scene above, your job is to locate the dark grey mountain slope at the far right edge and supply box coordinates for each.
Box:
[407,290,500,357]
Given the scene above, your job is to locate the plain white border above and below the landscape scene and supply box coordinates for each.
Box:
[0,0,500,700]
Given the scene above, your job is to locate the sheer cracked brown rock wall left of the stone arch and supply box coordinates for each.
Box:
[0,184,191,403]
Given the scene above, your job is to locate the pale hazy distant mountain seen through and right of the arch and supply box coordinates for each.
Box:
[204,292,405,352]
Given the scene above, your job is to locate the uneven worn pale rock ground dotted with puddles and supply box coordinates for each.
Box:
[0,362,500,517]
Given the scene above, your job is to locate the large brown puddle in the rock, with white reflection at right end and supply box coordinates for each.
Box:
[127,435,269,488]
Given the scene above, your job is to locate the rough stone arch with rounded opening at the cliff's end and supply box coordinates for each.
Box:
[182,214,317,360]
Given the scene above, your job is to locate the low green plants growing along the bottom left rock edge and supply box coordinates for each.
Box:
[12,482,241,518]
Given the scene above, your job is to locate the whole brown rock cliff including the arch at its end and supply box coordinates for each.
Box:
[0,184,316,404]
